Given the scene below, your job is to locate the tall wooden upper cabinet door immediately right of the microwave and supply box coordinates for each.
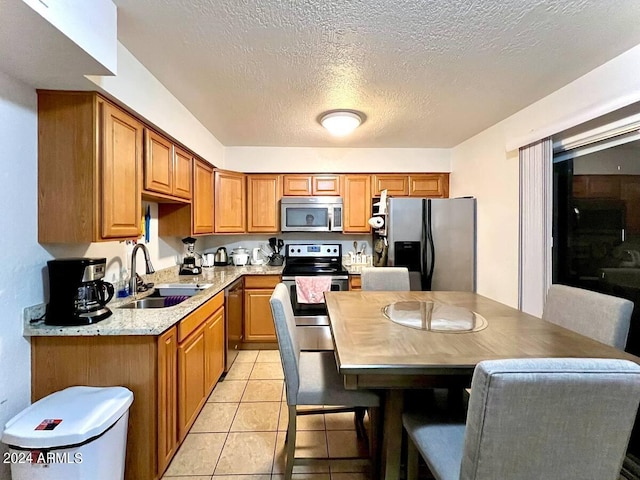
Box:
[343,175,371,233]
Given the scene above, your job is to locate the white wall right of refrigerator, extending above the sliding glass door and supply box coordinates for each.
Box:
[450,45,640,306]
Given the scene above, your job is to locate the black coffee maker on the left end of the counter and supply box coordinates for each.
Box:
[44,258,113,325]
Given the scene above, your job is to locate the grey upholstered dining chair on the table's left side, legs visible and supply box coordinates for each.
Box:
[270,283,380,480]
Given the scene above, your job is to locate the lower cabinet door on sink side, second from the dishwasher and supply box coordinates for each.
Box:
[178,325,207,441]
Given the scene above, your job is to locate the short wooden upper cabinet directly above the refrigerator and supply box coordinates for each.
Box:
[371,173,449,198]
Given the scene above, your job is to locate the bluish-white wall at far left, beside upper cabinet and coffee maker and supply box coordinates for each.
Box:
[0,69,50,478]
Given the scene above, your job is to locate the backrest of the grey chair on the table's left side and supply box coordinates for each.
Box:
[269,283,300,405]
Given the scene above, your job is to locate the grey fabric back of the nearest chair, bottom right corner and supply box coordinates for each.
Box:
[460,358,640,480]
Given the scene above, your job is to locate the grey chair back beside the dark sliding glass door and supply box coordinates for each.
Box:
[542,285,633,350]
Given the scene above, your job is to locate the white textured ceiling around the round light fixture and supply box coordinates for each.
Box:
[114,0,640,147]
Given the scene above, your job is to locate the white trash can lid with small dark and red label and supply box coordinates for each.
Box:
[2,387,133,449]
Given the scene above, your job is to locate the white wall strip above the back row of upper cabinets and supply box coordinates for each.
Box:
[225,147,451,173]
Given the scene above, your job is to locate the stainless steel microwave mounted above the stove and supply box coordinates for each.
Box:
[280,197,343,232]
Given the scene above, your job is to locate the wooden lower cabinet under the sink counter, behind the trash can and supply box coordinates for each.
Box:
[31,292,226,480]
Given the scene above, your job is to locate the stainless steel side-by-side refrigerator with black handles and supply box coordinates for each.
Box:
[385,198,476,292]
